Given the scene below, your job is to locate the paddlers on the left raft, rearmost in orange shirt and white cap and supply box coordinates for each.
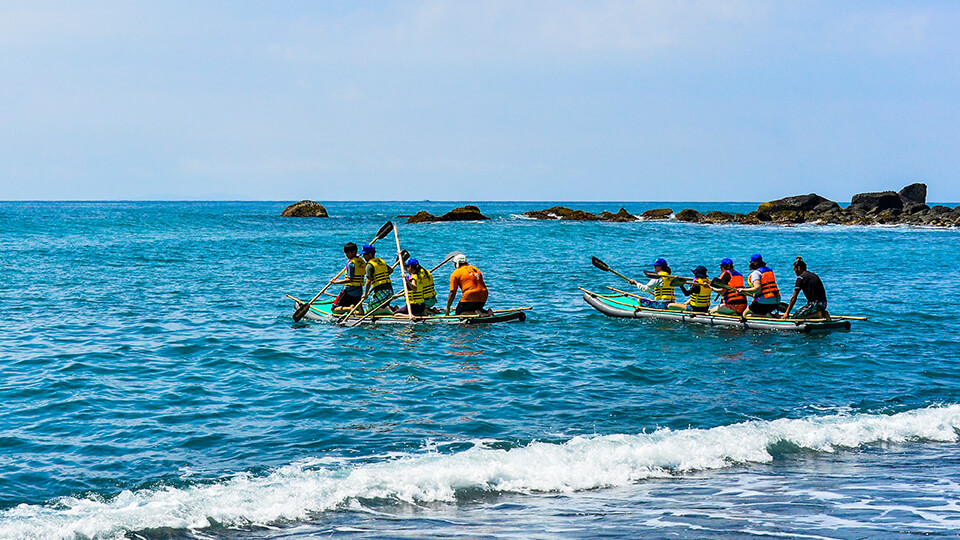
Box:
[332,242,489,317]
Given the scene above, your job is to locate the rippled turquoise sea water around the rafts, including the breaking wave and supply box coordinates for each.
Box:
[0,202,960,538]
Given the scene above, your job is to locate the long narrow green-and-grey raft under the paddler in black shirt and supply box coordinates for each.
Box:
[581,289,850,332]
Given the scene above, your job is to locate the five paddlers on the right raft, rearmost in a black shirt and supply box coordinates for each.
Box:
[628,254,830,321]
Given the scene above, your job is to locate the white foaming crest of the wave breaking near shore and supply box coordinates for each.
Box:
[0,405,960,538]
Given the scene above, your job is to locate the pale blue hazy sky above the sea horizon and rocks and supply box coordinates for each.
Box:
[0,0,960,202]
